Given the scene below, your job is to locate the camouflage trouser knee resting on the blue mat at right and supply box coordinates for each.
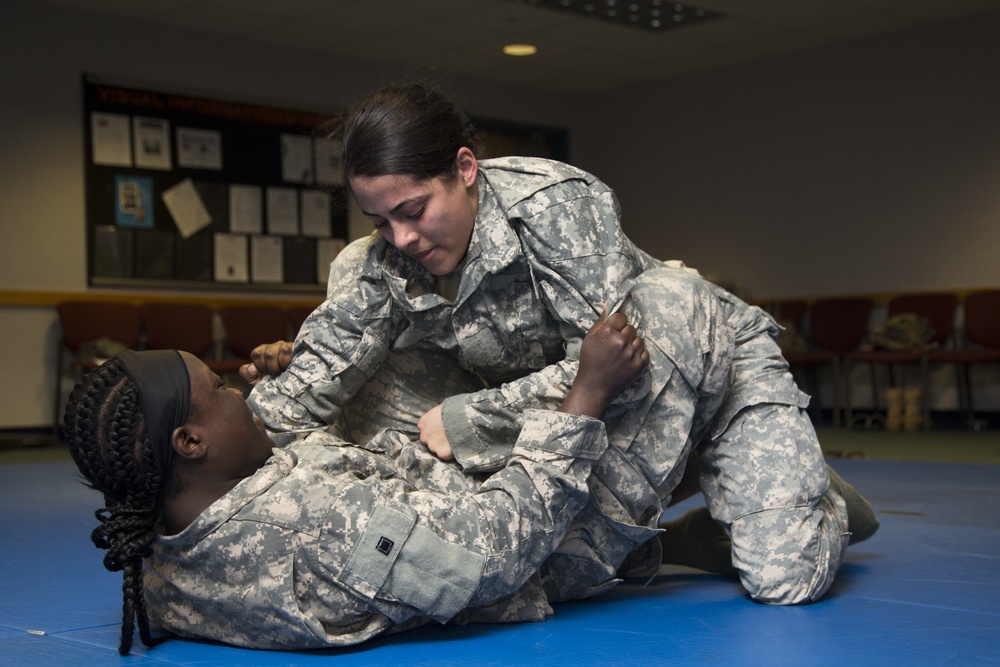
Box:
[732,494,849,605]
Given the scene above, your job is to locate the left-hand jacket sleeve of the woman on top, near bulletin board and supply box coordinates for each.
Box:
[247,239,398,444]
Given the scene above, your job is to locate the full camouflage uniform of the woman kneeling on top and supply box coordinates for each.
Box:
[249,158,847,604]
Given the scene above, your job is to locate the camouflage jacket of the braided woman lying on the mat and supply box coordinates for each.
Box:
[145,411,607,649]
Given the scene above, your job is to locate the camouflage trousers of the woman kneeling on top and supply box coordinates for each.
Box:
[341,269,849,604]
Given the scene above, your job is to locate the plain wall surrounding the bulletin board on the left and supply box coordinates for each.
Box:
[0,0,574,429]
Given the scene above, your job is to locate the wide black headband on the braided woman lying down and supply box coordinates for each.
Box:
[118,350,191,474]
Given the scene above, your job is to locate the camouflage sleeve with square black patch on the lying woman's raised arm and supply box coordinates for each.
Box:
[320,411,607,623]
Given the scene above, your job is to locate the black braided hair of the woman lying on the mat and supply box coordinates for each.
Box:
[64,359,169,655]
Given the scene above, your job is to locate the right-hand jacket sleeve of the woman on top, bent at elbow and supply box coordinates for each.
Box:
[442,180,660,472]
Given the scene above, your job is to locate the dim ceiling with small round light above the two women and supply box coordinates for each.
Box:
[35,0,1000,94]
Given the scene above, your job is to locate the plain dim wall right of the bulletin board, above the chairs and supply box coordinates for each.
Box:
[576,13,1000,298]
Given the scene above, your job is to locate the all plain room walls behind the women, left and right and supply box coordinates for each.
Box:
[0,0,1000,429]
